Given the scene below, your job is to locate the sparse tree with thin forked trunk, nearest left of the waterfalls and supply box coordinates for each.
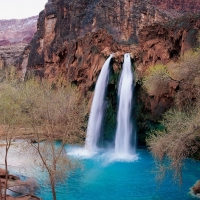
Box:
[20,81,86,200]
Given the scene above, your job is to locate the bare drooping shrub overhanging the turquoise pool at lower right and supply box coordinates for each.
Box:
[147,99,200,182]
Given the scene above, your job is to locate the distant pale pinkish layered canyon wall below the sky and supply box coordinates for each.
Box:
[0,16,38,69]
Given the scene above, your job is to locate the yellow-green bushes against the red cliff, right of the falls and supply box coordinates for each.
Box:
[143,49,200,98]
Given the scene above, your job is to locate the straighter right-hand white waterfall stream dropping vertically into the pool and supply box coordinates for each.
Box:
[115,54,135,156]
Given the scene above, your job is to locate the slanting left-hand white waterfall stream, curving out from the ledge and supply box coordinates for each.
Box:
[85,55,112,151]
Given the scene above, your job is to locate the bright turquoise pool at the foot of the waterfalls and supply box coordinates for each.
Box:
[19,147,200,200]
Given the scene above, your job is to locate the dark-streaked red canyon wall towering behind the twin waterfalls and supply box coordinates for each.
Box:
[15,0,200,144]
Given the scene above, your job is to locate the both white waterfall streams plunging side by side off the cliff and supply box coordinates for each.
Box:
[85,53,136,157]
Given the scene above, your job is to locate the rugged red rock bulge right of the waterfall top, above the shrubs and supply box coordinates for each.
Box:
[137,15,200,73]
